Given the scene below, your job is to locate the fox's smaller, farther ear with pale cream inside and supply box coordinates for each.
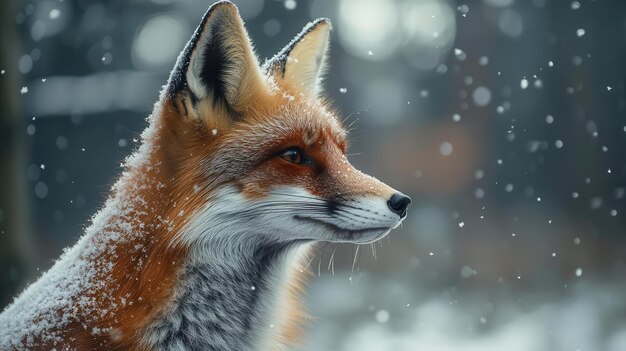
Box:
[264,18,332,96]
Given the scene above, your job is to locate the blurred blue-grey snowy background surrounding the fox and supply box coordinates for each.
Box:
[0,0,626,351]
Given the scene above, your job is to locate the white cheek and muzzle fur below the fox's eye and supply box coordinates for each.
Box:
[174,186,402,250]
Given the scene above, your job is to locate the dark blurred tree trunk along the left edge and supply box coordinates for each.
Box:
[0,0,34,309]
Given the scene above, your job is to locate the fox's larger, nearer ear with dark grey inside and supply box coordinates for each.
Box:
[168,1,265,111]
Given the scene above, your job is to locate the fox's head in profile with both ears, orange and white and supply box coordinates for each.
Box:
[156,2,411,252]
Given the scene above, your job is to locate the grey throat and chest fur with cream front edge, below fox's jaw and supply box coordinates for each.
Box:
[146,244,308,350]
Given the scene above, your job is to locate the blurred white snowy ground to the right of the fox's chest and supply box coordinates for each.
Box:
[296,272,626,351]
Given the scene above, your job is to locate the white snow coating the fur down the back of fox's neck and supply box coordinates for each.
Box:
[0,103,160,350]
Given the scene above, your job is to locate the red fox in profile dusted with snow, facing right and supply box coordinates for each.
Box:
[0,1,411,351]
